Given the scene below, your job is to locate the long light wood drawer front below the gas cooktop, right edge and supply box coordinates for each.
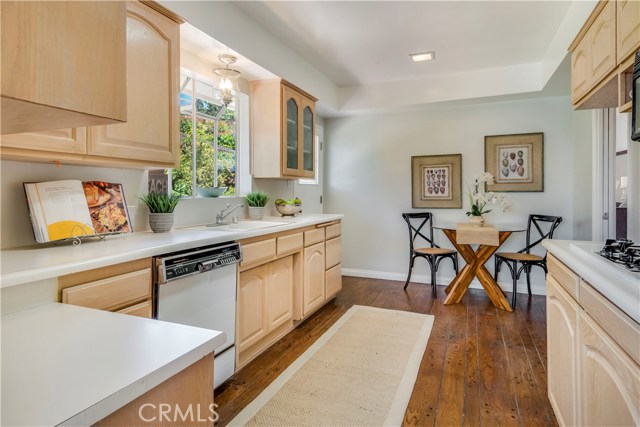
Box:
[580,281,640,363]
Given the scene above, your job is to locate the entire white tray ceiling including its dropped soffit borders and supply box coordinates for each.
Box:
[169,0,597,116]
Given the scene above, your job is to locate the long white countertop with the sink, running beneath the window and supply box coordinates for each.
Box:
[0,214,344,288]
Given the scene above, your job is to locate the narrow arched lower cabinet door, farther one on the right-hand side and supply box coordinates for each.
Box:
[547,275,579,426]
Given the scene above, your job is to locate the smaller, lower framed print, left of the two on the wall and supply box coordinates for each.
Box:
[411,154,462,209]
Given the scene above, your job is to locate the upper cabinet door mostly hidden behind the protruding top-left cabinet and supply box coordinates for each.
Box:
[0,128,87,160]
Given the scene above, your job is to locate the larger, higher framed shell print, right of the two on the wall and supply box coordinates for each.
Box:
[484,132,544,192]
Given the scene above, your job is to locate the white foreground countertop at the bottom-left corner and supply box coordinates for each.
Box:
[1,303,225,426]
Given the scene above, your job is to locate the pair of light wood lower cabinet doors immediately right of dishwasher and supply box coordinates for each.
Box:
[236,255,293,352]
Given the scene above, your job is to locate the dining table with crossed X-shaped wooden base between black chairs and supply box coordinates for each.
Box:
[433,222,527,311]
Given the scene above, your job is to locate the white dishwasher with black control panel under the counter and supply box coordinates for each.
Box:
[154,242,242,387]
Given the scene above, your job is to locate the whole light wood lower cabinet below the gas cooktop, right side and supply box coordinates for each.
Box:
[547,258,640,426]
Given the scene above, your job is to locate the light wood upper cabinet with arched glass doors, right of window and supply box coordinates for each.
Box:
[251,79,317,179]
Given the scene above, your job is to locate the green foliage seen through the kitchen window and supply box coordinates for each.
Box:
[172,107,236,196]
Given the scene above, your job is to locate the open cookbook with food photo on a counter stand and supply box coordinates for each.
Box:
[24,180,133,243]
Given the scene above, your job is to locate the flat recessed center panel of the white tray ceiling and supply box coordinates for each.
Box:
[237,1,571,87]
